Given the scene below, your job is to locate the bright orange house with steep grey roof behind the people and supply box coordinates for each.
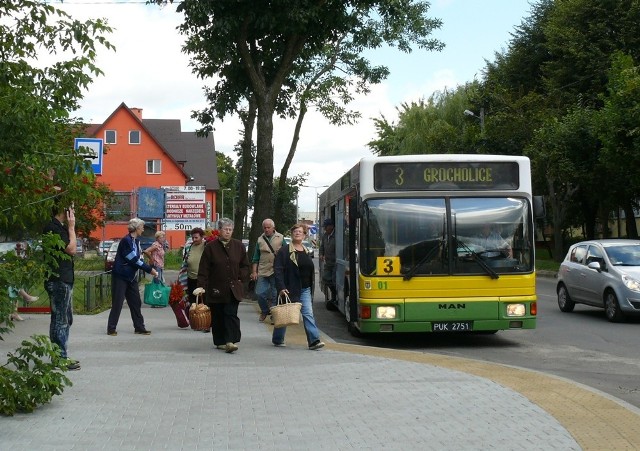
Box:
[87,103,220,248]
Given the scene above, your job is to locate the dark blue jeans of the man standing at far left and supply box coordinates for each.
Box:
[44,280,73,359]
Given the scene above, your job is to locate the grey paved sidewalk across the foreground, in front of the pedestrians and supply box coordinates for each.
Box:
[0,302,640,450]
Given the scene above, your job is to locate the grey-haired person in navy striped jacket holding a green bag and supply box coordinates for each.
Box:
[107,218,158,336]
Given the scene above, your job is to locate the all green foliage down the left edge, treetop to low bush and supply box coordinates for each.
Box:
[0,0,112,415]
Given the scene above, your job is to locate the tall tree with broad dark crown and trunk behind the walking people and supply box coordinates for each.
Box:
[156,0,440,247]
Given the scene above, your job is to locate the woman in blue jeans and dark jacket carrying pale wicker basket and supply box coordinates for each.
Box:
[271,224,324,351]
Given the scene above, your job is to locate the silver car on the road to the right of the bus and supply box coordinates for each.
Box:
[556,239,640,322]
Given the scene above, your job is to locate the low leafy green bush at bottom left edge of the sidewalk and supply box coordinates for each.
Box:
[0,335,72,416]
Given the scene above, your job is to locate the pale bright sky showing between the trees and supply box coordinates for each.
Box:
[51,0,531,217]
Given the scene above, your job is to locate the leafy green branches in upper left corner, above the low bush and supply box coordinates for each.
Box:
[0,0,112,236]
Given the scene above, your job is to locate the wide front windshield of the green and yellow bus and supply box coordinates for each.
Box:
[359,197,533,279]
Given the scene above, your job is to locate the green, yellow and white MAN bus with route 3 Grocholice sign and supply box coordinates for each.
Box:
[318,154,543,335]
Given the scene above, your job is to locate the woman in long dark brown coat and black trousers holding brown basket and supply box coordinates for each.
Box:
[193,218,249,353]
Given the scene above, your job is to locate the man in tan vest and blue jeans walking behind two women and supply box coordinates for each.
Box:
[251,218,284,322]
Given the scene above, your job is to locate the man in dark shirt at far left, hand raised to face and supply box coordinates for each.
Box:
[43,207,80,370]
